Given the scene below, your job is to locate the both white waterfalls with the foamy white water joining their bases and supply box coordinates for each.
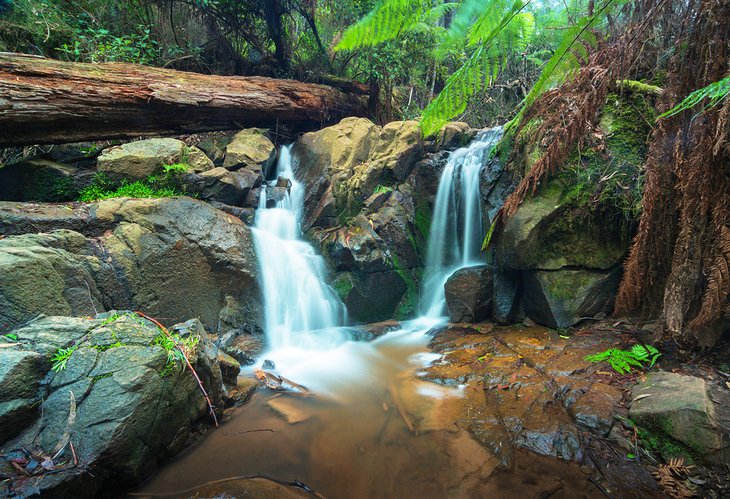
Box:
[253,129,501,400]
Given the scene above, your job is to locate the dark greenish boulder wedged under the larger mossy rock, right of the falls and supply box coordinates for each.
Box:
[523,268,621,328]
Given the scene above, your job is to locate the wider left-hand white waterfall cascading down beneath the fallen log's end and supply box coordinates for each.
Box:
[252,146,346,350]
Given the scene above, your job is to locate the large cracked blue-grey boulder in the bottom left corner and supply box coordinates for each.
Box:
[0,313,223,497]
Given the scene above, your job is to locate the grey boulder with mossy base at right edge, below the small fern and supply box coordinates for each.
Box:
[629,371,730,465]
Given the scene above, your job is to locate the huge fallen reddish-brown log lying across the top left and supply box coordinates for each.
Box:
[0,53,367,147]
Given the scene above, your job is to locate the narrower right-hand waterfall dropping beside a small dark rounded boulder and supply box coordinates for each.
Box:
[421,127,502,319]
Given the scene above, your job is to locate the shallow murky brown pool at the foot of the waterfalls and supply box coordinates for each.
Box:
[134,335,602,499]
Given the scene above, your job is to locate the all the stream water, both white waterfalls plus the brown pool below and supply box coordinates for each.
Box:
[135,130,590,499]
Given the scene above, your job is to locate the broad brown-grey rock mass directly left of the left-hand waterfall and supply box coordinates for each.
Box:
[0,197,262,332]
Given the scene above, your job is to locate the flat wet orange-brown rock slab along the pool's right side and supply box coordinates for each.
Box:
[422,325,623,467]
